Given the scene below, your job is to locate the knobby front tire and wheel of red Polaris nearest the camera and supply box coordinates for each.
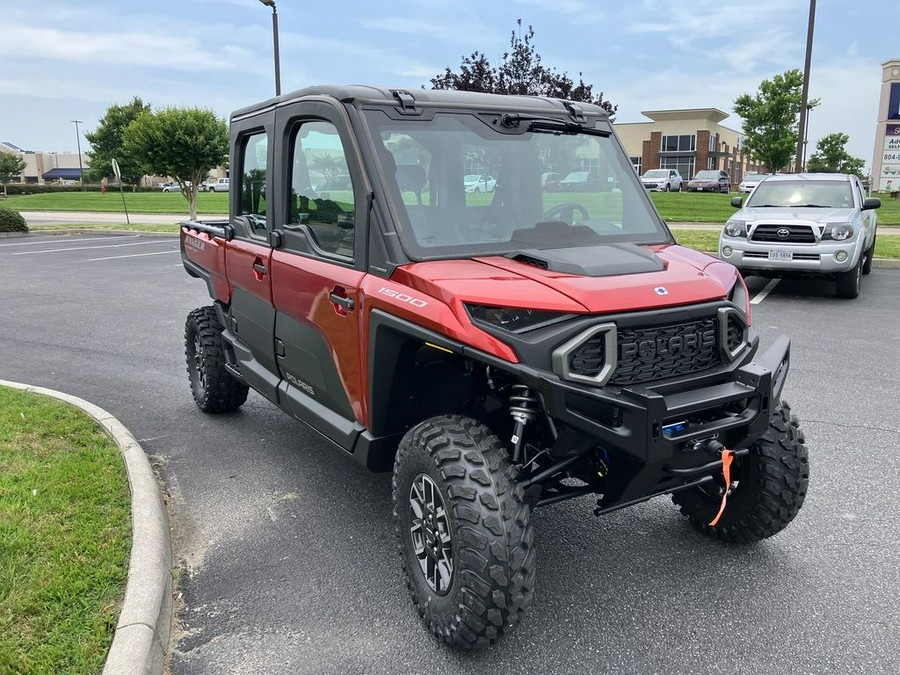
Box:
[393,415,535,649]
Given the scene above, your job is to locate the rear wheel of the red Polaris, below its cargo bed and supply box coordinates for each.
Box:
[184,306,249,413]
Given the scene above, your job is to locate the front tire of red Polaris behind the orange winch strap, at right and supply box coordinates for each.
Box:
[672,401,809,543]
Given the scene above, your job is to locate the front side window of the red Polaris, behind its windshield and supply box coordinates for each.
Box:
[285,121,356,258]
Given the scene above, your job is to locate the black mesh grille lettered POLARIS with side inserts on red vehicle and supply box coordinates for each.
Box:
[568,318,724,387]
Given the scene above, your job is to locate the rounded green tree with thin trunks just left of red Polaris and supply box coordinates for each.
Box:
[123,107,229,220]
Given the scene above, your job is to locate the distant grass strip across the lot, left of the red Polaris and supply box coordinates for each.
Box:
[2,191,228,216]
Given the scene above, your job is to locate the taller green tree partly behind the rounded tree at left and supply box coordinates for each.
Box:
[84,96,150,186]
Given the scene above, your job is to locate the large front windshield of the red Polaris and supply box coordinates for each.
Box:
[366,110,672,258]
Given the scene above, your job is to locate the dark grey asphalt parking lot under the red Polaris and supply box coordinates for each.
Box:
[0,235,900,675]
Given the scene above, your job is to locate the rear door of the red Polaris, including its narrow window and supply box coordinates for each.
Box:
[225,112,279,401]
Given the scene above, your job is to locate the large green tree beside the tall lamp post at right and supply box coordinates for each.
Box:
[734,68,819,173]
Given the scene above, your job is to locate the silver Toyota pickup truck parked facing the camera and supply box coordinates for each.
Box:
[719,173,881,298]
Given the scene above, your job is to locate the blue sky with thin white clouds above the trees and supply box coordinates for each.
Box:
[0,0,900,166]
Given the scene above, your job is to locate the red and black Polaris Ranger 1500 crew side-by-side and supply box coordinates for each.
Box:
[181,86,809,648]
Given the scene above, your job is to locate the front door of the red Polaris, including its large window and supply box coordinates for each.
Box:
[272,100,367,450]
